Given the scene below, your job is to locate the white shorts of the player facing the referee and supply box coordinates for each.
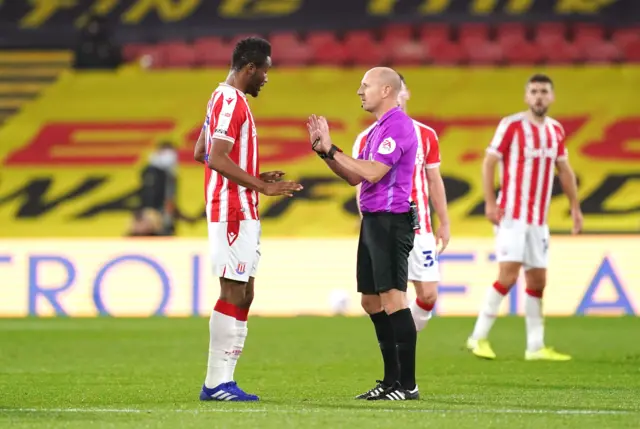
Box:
[209,219,261,282]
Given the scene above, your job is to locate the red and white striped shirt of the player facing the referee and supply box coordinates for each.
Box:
[204,83,260,222]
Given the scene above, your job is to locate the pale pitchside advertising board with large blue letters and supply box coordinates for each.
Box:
[0,237,640,317]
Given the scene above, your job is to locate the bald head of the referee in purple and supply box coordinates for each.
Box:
[358,67,402,116]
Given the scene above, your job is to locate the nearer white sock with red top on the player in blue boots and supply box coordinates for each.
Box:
[204,300,236,389]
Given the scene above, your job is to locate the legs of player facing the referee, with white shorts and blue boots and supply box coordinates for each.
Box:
[200,221,259,401]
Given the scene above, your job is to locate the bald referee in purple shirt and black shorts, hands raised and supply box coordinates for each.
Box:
[307,67,419,401]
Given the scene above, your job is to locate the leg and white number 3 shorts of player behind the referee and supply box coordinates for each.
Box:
[408,233,440,332]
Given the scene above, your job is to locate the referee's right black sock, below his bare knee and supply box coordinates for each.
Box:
[389,308,418,390]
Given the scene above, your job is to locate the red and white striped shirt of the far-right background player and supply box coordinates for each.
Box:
[487,113,567,225]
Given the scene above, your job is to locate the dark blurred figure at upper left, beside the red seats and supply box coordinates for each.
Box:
[73,16,122,69]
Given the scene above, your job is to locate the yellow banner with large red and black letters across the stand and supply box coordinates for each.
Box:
[0,66,640,237]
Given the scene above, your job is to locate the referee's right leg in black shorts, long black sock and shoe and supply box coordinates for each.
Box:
[370,216,419,400]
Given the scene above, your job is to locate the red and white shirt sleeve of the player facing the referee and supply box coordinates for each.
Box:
[209,93,246,143]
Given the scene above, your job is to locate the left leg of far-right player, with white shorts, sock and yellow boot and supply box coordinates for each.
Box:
[467,221,526,359]
